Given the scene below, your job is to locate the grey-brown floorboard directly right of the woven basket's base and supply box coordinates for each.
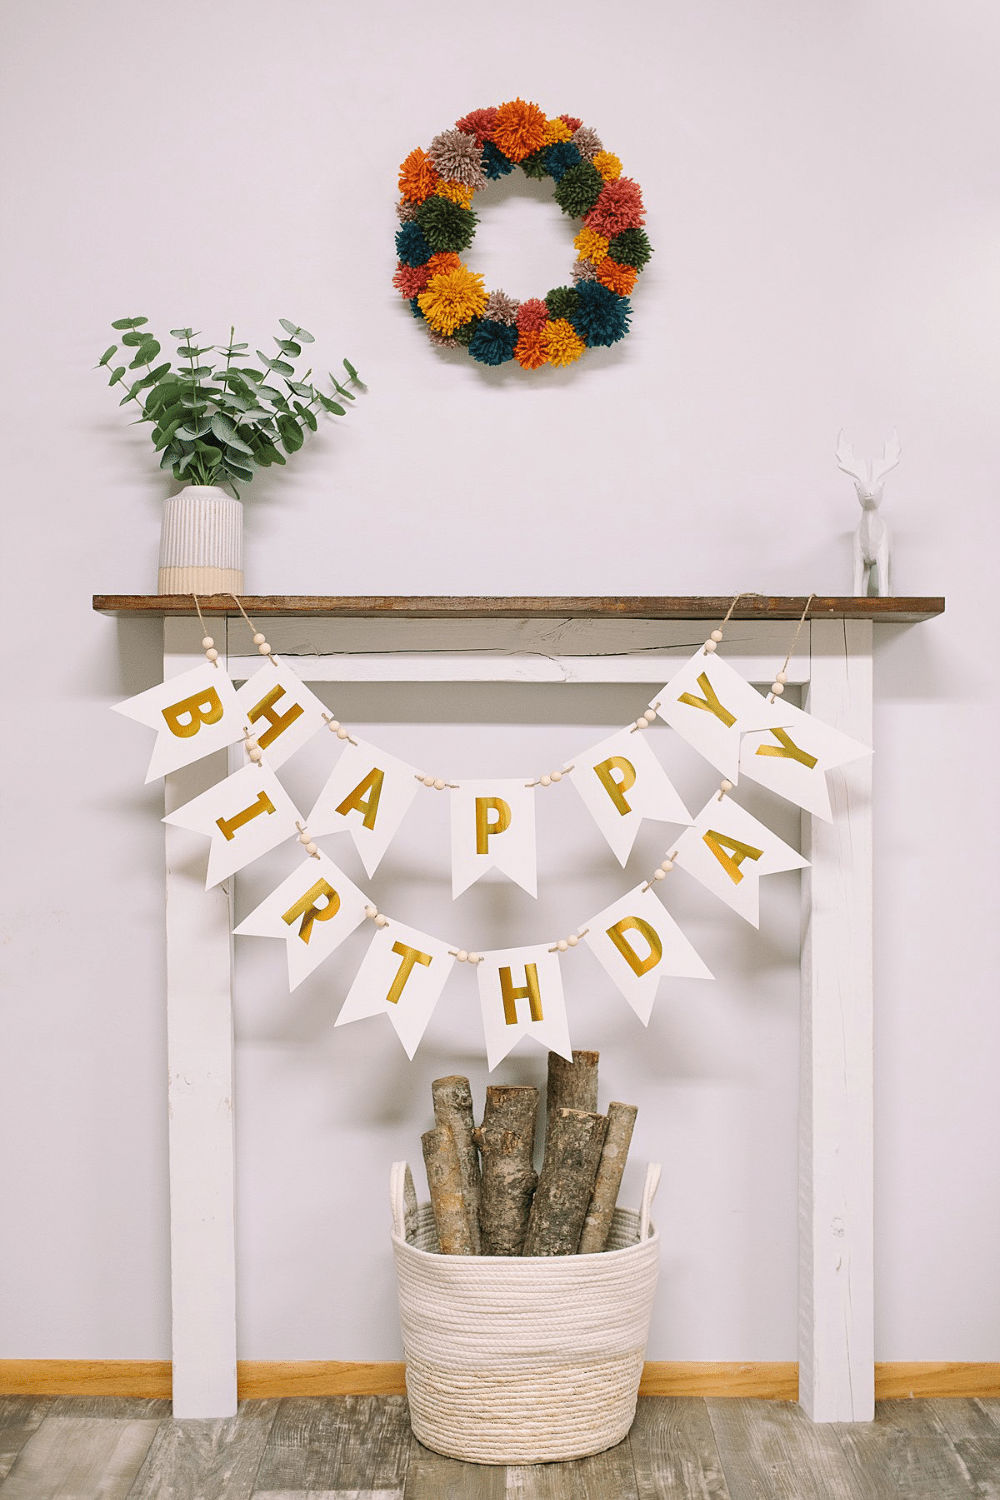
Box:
[628,1397,730,1500]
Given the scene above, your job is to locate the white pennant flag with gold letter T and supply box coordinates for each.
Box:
[336,920,454,1059]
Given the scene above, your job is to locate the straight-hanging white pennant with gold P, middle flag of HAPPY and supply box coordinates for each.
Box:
[451,782,538,899]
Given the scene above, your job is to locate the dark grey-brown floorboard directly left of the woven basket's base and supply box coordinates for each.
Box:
[256,1397,414,1493]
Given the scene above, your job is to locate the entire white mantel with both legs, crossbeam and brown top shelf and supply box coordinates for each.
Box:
[94,596,945,1422]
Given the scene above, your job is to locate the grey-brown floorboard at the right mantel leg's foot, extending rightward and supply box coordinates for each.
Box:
[838,1401,976,1500]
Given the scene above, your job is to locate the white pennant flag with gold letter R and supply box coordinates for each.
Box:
[234,854,370,990]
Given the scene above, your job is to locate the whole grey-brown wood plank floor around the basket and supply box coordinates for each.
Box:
[0,1397,1000,1500]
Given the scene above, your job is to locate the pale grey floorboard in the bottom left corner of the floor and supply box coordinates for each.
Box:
[0,1416,159,1500]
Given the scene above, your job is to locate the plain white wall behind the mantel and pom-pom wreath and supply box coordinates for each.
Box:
[0,0,1000,1361]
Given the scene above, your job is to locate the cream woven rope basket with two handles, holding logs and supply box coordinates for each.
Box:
[390,1161,660,1464]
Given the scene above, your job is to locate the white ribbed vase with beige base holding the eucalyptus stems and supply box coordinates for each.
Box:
[156,485,243,594]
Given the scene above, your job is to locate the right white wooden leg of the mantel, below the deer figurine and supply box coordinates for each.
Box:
[799,620,874,1422]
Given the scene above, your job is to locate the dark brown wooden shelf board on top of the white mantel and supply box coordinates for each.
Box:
[93,594,945,626]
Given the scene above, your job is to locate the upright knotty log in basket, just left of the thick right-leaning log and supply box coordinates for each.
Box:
[474,1085,538,1256]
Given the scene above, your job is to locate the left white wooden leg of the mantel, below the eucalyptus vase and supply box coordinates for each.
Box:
[163,620,237,1418]
